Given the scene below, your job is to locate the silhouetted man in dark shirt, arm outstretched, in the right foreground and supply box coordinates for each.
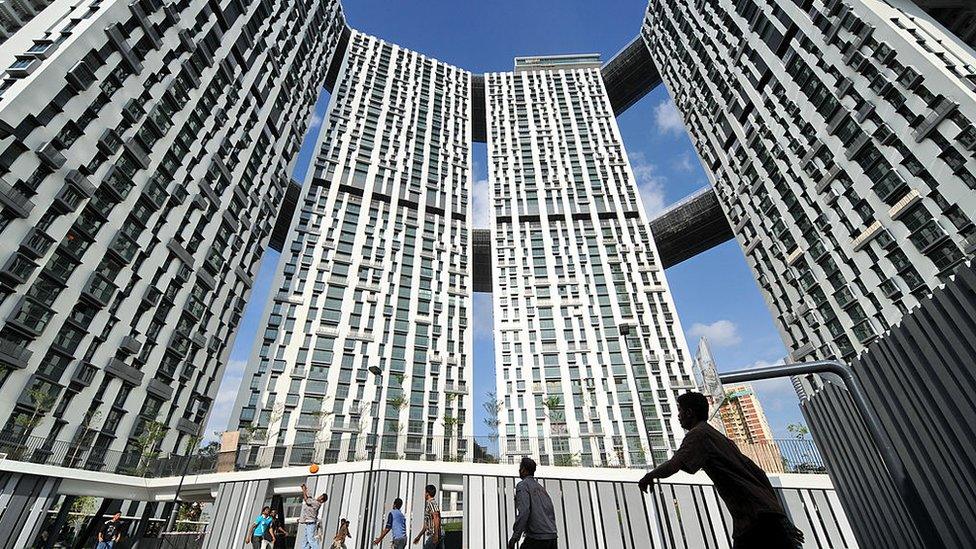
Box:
[638,392,803,549]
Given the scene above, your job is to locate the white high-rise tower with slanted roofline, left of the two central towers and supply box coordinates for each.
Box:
[230,32,473,463]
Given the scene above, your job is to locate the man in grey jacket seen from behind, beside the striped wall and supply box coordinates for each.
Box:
[508,457,557,549]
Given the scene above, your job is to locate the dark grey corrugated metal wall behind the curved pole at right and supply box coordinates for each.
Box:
[802,264,976,548]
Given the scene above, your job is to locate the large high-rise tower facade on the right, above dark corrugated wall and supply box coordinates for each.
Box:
[642,0,976,360]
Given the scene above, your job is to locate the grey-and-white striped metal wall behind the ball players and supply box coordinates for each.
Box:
[205,470,857,549]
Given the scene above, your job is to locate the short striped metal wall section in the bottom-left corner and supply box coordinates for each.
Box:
[0,472,60,549]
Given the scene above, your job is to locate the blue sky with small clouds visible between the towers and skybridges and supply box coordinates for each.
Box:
[207,0,801,437]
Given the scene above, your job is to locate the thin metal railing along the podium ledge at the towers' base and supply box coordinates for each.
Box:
[0,433,826,477]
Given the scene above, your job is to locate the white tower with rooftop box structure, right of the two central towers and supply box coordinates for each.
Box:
[485,56,694,465]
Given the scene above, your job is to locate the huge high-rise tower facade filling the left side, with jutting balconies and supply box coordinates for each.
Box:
[0,0,345,466]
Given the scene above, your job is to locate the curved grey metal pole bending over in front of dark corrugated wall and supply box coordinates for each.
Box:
[718,360,942,549]
